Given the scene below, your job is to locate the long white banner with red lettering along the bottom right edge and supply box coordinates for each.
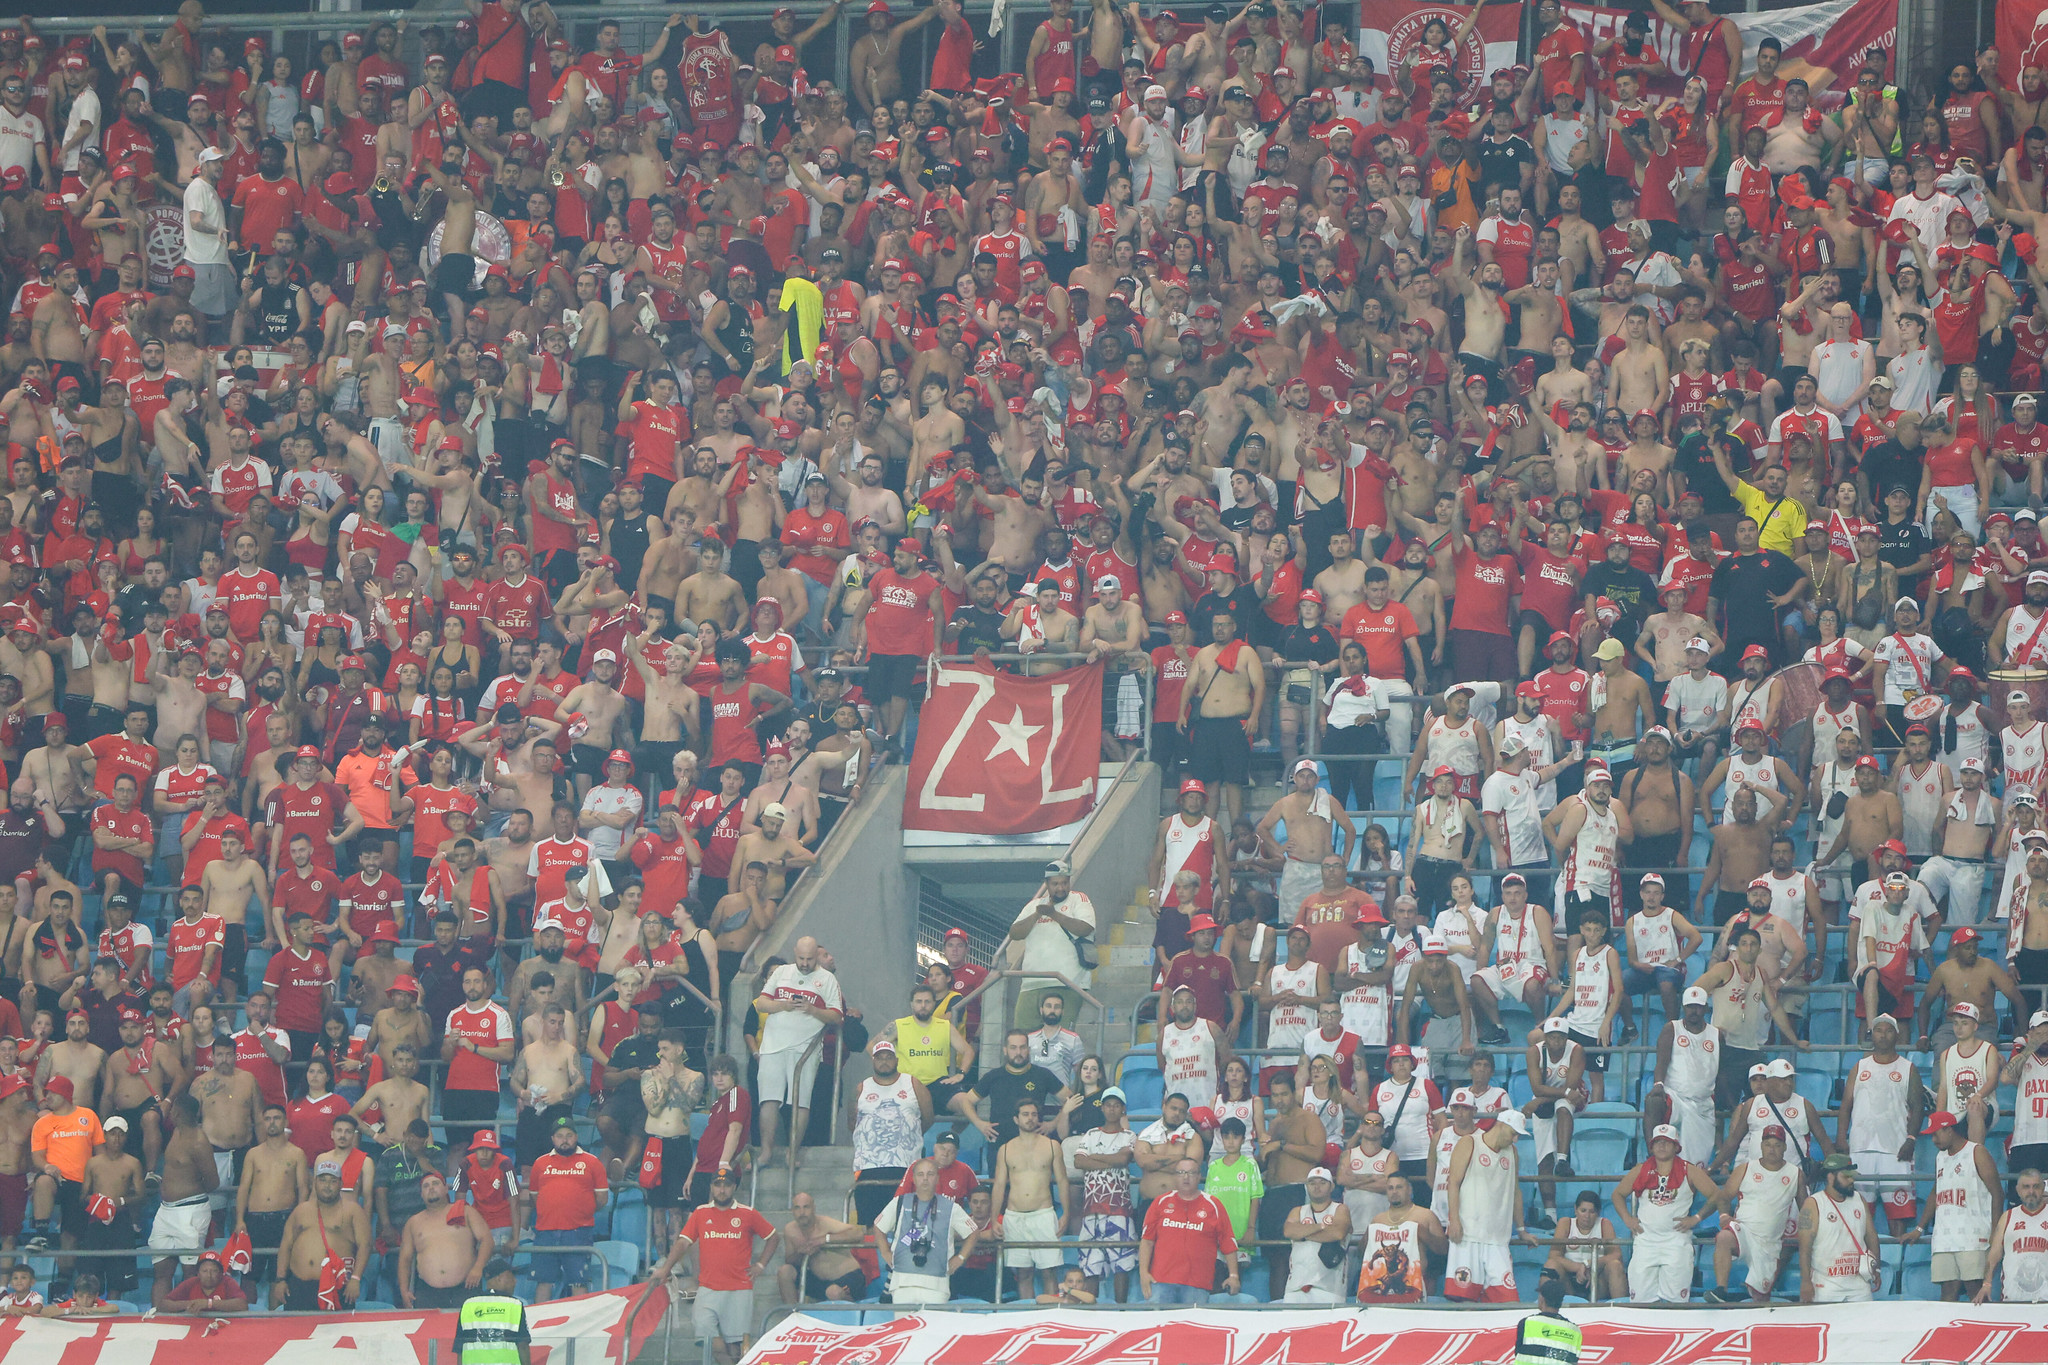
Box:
[741,1300,2048,1365]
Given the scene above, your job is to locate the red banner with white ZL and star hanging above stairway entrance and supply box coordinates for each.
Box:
[903,663,1102,835]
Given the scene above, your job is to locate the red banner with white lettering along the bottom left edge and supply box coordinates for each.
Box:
[0,1285,668,1365]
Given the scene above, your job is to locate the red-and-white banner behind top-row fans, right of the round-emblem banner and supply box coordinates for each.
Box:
[1565,0,1900,108]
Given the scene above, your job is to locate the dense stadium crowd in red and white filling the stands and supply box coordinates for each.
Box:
[0,0,2048,1361]
